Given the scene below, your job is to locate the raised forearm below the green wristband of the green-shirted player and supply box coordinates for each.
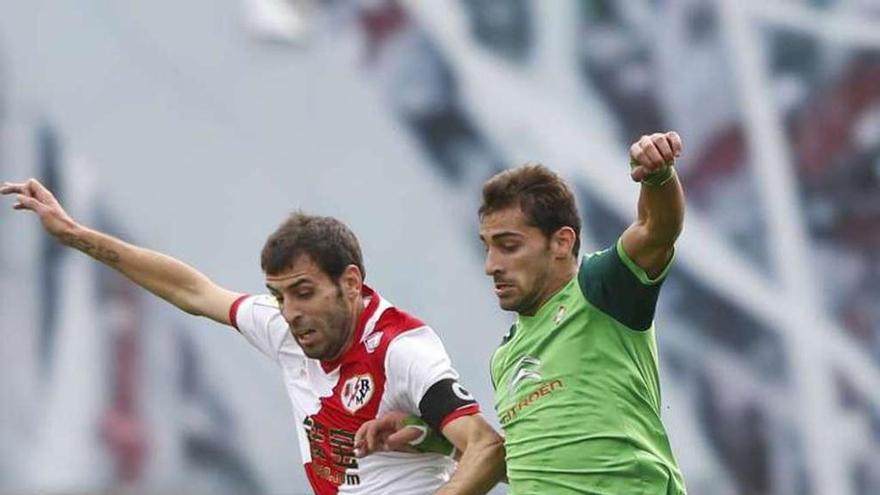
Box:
[638,172,684,249]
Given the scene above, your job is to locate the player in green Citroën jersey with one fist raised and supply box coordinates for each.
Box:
[360,132,686,495]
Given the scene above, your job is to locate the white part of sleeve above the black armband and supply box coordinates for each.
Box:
[385,326,458,416]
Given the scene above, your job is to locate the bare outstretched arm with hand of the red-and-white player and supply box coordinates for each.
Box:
[0,179,239,325]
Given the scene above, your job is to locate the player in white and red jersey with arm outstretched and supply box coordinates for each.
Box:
[0,179,504,495]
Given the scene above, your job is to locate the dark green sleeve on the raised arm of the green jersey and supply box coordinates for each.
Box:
[578,239,674,330]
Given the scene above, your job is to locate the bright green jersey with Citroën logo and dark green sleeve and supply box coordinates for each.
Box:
[492,241,685,495]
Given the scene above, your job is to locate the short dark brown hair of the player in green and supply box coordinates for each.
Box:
[479,164,581,256]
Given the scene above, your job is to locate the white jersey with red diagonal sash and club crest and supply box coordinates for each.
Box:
[230,286,479,495]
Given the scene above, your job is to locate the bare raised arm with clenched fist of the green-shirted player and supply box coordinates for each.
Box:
[621,132,684,278]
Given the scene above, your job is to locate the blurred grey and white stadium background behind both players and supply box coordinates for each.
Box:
[0,0,880,495]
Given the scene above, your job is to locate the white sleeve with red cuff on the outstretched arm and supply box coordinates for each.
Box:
[229,295,287,363]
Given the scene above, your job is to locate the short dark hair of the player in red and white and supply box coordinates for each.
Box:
[260,211,367,281]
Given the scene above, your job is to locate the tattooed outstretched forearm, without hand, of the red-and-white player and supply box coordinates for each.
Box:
[57,225,222,315]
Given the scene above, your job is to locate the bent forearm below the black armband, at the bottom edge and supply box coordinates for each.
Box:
[437,436,506,495]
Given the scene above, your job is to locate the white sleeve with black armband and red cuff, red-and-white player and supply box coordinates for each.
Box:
[385,327,480,432]
